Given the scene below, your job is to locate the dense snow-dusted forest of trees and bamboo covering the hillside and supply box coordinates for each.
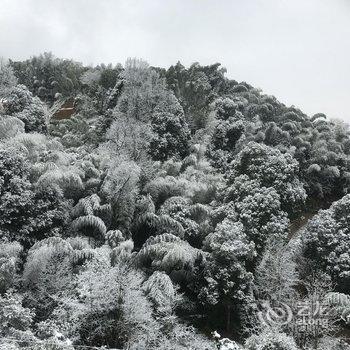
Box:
[0,53,350,350]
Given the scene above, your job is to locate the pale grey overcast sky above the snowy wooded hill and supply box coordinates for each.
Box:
[0,0,350,123]
